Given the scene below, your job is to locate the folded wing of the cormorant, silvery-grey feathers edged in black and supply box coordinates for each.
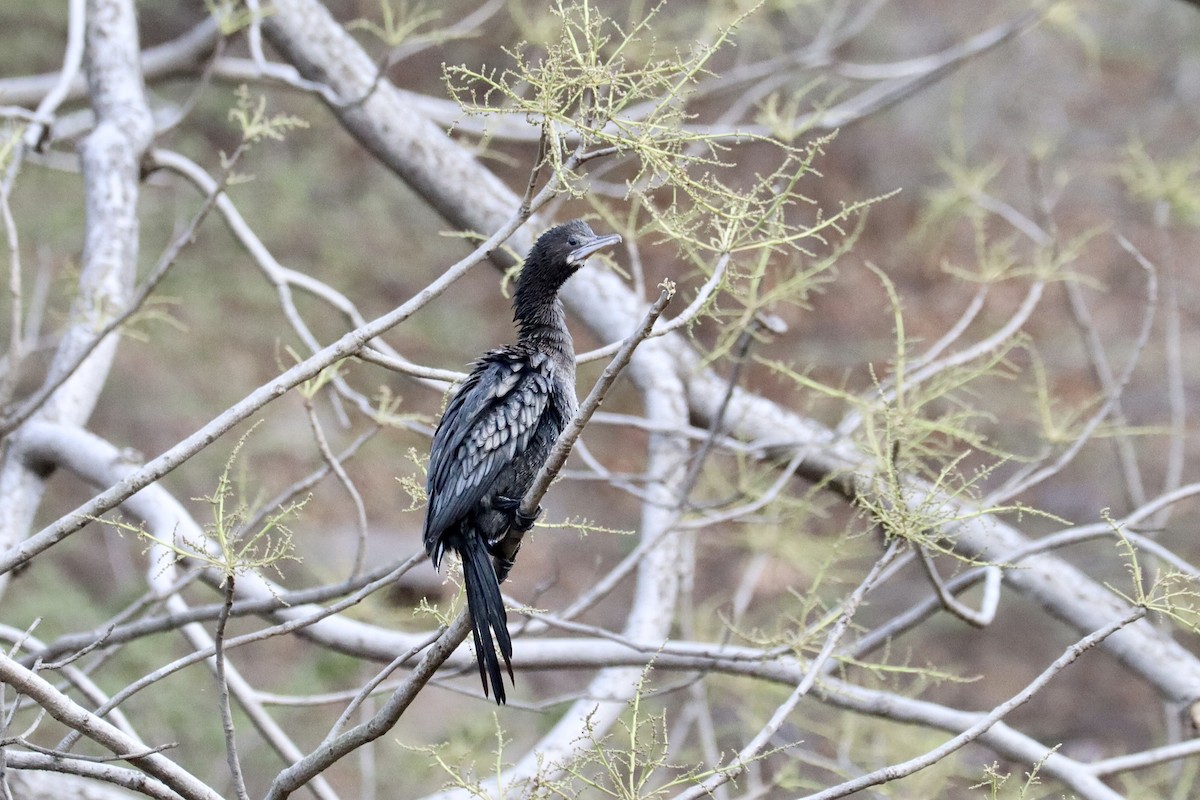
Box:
[425,350,554,548]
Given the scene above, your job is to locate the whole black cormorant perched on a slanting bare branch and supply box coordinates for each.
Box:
[425,219,620,703]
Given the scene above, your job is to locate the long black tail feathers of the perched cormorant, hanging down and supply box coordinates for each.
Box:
[458,536,512,703]
